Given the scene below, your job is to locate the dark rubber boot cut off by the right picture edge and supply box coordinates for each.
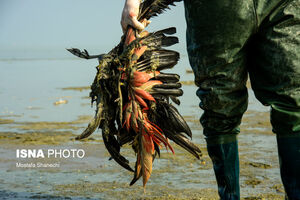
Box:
[277,134,300,200]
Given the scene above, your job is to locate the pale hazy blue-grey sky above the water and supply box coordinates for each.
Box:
[0,0,186,55]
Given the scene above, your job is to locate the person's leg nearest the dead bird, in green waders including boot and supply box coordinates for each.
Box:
[185,0,255,199]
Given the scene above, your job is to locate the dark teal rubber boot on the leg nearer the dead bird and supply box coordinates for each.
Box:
[206,135,240,200]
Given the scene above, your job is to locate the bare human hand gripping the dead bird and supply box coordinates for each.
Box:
[121,0,149,32]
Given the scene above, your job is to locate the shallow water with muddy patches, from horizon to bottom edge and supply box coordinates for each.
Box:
[0,52,284,199]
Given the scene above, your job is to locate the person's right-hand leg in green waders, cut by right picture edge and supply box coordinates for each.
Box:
[249,0,300,199]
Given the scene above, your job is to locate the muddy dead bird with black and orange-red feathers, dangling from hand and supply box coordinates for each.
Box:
[68,0,201,187]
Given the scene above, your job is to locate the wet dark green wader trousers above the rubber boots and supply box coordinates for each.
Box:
[185,0,300,137]
